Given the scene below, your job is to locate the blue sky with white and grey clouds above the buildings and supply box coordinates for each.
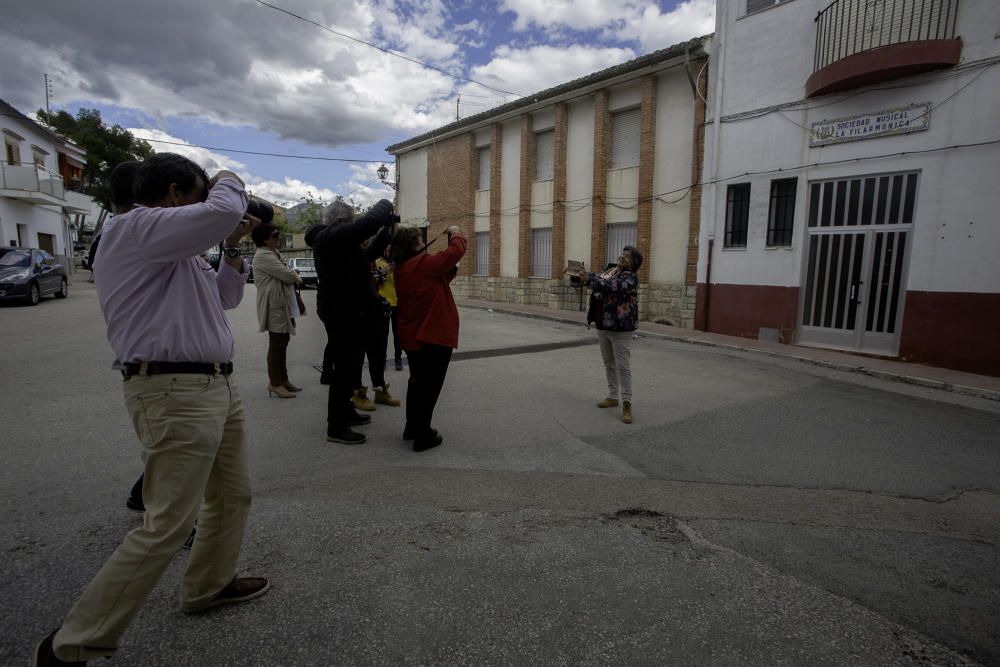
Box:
[0,0,715,209]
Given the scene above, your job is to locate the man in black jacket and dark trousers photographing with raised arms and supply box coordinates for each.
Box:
[306,199,399,445]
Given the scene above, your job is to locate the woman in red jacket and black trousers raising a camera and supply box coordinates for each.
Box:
[391,227,467,452]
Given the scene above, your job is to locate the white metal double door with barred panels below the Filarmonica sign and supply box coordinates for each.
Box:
[802,173,918,353]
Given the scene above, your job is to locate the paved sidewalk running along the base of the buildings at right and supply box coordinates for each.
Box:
[455,298,1000,401]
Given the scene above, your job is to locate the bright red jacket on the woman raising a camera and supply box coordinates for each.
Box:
[395,234,468,350]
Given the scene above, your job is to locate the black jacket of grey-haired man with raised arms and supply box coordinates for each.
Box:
[306,199,397,317]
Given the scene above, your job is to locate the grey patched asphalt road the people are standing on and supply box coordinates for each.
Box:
[0,278,1000,665]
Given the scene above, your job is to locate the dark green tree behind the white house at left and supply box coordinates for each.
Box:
[36,109,153,210]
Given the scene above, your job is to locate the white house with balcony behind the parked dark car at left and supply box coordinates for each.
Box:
[0,100,94,273]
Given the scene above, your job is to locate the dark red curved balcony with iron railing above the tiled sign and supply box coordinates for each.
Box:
[806,0,962,97]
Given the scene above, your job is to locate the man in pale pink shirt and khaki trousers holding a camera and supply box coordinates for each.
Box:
[34,153,270,665]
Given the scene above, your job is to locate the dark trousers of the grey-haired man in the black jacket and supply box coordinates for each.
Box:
[319,314,365,433]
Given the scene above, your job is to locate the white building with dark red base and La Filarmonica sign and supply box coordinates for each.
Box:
[695,0,1000,375]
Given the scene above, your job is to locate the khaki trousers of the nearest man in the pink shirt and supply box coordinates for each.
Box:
[53,374,250,661]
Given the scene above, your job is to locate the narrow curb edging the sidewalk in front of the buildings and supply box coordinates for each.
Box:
[458,303,1000,402]
